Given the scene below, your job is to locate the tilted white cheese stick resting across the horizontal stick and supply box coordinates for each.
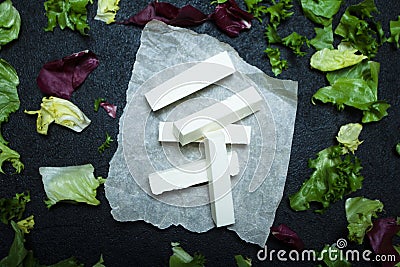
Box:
[173,87,264,145]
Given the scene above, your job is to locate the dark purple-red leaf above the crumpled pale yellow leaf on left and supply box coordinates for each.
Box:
[36,50,99,100]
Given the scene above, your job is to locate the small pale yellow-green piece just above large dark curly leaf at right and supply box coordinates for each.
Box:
[336,123,363,154]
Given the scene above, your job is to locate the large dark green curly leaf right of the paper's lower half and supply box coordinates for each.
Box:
[289,145,364,213]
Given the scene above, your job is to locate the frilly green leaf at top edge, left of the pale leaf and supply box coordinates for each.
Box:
[44,0,92,35]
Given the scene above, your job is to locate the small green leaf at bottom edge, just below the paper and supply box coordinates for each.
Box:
[169,243,206,267]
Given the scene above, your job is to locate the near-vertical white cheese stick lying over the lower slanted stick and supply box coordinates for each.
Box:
[204,130,235,227]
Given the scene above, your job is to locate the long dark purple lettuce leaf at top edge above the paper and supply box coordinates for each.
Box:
[122,2,208,27]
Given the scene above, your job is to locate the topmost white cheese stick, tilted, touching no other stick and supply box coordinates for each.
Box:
[144,51,235,111]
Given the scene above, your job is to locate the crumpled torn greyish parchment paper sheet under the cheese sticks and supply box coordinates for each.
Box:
[105,21,297,246]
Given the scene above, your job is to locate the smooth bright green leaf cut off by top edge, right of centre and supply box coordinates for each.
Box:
[301,0,343,26]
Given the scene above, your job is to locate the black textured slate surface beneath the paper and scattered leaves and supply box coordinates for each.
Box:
[0,0,400,266]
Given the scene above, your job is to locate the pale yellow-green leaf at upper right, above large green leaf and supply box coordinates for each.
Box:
[310,43,367,71]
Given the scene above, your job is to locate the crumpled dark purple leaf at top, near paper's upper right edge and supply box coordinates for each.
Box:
[210,0,254,37]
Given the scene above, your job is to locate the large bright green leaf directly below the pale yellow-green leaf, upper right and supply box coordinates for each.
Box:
[312,60,390,123]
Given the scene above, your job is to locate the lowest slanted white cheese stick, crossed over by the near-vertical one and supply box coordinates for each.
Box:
[149,152,239,195]
